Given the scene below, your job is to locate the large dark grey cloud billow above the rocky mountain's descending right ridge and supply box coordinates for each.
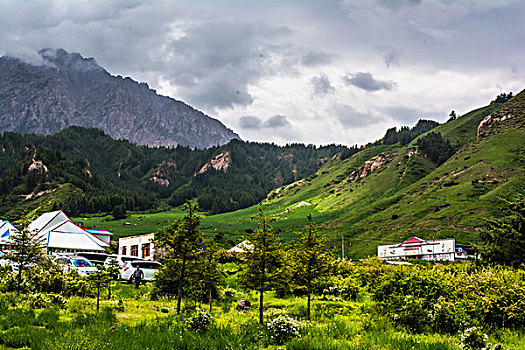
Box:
[163,20,290,109]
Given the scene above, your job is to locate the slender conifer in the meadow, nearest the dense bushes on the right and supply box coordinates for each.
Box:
[290,214,332,319]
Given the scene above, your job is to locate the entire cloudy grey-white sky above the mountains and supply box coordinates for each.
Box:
[0,0,525,145]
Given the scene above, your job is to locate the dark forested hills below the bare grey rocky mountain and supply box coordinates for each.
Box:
[0,127,348,216]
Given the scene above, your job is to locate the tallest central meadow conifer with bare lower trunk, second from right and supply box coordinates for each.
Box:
[239,208,283,324]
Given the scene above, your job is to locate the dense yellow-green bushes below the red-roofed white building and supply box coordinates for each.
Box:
[370,265,525,334]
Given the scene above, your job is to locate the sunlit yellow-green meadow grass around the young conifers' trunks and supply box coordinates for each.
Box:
[4,264,525,350]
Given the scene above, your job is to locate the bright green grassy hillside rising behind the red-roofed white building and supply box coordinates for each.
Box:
[75,92,525,257]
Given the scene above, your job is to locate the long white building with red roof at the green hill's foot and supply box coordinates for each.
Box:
[377,237,457,261]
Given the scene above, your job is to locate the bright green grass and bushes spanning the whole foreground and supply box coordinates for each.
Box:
[0,259,525,350]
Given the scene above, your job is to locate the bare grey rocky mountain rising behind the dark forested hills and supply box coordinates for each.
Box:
[0,49,239,148]
